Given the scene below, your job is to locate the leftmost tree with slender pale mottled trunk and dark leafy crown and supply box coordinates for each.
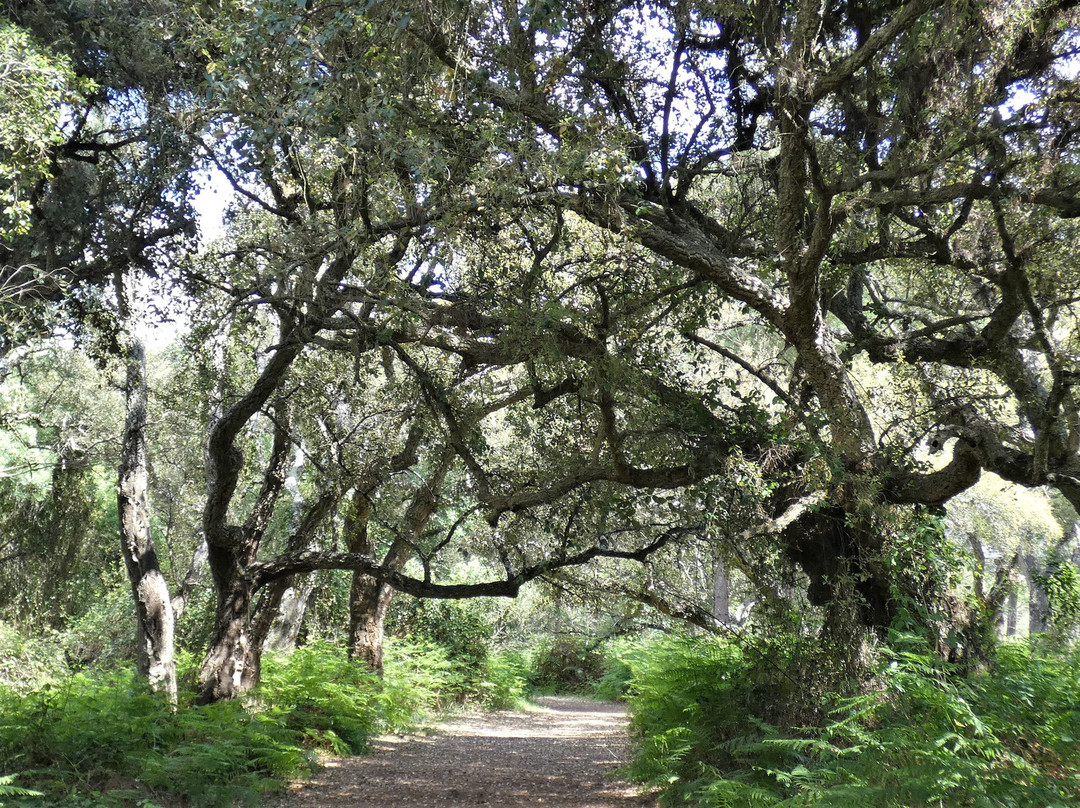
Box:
[0,3,203,698]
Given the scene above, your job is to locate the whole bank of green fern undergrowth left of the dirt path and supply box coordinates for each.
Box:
[0,643,524,808]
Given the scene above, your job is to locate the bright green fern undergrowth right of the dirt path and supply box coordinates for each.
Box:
[620,635,1080,808]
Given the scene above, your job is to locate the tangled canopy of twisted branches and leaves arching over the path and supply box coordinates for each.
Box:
[0,0,1080,700]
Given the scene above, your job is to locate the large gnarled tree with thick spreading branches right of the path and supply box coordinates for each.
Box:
[386,0,1080,648]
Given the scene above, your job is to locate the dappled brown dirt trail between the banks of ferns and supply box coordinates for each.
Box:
[274,697,654,808]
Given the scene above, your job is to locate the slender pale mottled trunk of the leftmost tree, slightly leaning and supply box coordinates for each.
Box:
[114,272,176,703]
